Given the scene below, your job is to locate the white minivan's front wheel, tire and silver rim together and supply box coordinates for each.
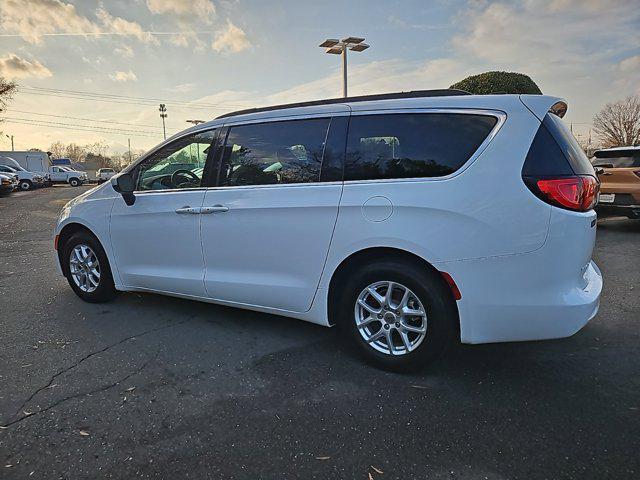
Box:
[61,232,117,303]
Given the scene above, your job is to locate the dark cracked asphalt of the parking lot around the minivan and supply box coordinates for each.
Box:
[0,187,640,480]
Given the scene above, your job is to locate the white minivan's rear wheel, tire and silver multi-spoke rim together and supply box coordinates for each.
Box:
[336,259,458,371]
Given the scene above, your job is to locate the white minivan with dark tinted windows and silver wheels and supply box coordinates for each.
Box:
[55,90,602,369]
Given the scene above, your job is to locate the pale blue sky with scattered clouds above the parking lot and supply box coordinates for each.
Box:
[0,0,640,151]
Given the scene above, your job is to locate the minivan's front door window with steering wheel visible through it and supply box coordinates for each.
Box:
[136,130,216,191]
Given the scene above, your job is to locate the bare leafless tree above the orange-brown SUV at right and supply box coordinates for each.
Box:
[593,95,640,148]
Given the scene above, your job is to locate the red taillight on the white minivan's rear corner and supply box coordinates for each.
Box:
[536,175,600,212]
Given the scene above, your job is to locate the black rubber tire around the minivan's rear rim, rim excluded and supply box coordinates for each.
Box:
[334,258,458,372]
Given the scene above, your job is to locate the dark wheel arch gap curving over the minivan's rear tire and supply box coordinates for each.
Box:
[327,247,460,338]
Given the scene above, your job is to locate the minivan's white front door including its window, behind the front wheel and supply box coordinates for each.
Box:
[110,130,216,296]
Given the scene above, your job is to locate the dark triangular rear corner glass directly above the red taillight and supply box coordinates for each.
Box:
[522,113,595,177]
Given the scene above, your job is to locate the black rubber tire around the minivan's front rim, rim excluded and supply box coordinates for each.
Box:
[61,231,117,303]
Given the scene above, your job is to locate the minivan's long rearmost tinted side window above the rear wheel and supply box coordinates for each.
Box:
[344,113,498,180]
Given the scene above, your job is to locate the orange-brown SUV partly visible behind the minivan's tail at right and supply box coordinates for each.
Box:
[591,146,640,219]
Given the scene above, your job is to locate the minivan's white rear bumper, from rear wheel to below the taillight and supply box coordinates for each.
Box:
[435,209,602,343]
